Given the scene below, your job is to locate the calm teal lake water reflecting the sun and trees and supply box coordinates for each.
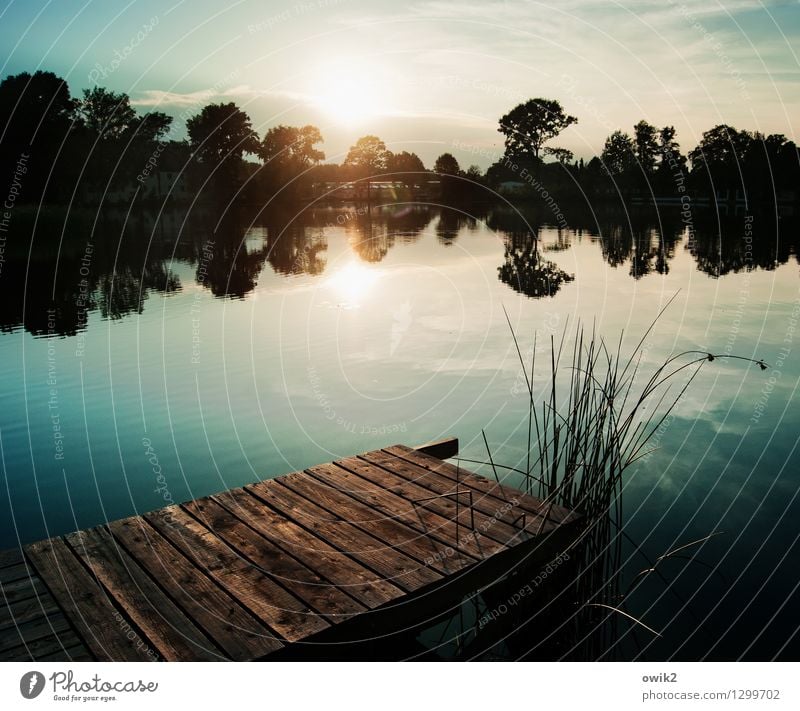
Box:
[0,205,800,659]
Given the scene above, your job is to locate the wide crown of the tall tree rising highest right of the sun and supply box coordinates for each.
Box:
[497,99,578,158]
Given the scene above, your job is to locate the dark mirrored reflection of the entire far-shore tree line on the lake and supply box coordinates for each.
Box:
[0,199,797,336]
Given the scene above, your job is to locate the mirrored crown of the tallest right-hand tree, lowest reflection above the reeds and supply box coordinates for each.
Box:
[498,234,575,298]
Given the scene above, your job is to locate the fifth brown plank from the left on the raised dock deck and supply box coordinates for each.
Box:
[185,495,368,622]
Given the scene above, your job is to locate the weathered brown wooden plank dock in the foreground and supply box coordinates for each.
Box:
[0,440,579,661]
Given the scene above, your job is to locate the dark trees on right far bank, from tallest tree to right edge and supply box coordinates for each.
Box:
[485,99,800,210]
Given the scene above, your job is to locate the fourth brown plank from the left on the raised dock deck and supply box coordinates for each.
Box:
[145,506,330,642]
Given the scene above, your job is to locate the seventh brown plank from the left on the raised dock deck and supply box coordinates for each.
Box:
[244,477,442,592]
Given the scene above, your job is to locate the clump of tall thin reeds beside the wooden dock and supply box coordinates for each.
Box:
[464,294,767,659]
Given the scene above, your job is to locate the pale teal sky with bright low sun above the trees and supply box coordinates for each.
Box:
[0,0,800,168]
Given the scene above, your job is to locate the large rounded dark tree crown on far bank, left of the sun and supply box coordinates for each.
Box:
[186,102,261,166]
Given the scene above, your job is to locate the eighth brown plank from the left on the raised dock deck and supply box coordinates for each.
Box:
[270,473,466,574]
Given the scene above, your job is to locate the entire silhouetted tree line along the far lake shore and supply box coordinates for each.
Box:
[0,71,800,203]
